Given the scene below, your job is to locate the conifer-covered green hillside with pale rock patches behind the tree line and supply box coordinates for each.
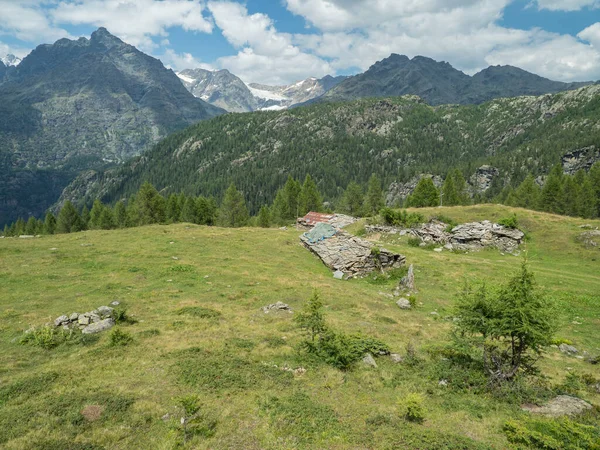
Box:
[62,86,600,213]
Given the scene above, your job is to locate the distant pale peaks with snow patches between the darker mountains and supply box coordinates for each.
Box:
[177,69,346,112]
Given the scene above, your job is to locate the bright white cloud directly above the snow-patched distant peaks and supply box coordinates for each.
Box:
[208,1,333,84]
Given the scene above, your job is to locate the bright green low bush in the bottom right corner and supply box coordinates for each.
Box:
[503,418,600,450]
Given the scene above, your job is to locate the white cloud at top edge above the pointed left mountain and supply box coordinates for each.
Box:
[50,0,213,51]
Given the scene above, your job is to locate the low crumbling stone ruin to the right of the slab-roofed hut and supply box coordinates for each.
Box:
[365,220,525,253]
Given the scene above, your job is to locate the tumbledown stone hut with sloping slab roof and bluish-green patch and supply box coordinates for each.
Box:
[300,223,406,278]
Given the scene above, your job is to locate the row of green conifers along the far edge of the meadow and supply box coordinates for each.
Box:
[3,162,600,236]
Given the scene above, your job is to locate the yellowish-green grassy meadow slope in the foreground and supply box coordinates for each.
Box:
[0,206,600,449]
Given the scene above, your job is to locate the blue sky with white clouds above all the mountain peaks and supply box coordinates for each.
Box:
[0,0,600,84]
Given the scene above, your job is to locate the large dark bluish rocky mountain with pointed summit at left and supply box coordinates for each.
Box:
[0,28,225,223]
